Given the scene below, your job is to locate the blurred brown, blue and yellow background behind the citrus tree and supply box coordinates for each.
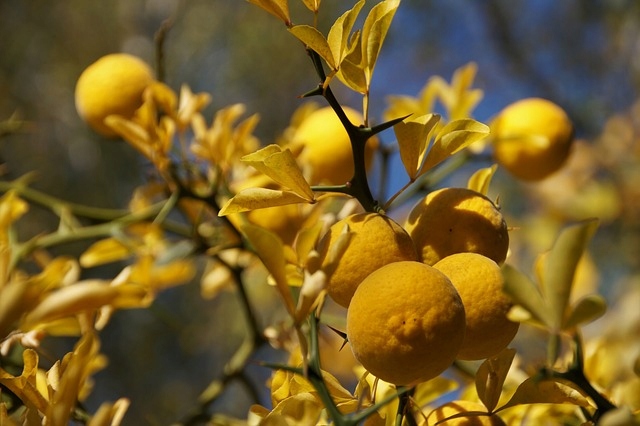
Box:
[0,0,640,425]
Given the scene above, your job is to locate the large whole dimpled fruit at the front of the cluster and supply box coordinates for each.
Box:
[347,261,465,386]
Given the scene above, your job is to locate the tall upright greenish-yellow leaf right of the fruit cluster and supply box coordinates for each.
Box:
[540,219,598,330]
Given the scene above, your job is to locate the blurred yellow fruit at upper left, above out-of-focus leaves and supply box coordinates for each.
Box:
[75,53,154,137]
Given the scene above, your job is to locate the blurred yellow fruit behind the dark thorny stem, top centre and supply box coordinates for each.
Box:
[292,107,378,185]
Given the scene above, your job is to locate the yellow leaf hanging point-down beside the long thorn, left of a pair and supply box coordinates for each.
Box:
[393,114,440,179]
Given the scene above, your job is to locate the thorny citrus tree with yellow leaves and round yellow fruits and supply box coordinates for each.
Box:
[0,0,640,425]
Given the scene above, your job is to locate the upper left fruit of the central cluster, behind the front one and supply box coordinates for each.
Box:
[318,213,418,307]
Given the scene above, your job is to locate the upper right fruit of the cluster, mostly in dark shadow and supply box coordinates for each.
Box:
[405,188,509,265]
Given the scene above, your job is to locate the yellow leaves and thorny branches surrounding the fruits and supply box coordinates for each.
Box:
[0,0,640,425]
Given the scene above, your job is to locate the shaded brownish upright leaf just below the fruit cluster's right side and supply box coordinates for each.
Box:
[476,349,516,412]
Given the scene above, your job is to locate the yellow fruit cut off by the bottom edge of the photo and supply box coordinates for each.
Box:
[427,401,506,426]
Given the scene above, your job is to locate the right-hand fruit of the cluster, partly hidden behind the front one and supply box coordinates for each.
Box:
[433,253,520,360]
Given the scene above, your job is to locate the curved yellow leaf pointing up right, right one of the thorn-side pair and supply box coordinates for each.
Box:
[421,118,489,174]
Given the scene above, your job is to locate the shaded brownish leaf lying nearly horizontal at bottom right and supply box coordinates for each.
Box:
[499,377,590,410]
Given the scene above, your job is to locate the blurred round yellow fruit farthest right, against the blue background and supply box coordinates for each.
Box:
[491,98,574,181]
